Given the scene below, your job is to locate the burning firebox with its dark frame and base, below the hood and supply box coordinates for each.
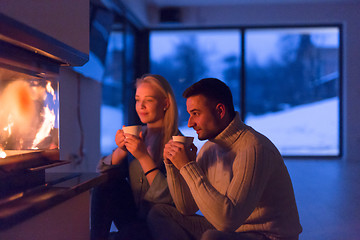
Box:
[0,41,68,199]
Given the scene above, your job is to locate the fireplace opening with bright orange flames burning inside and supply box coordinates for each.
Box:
[0,64,59,158]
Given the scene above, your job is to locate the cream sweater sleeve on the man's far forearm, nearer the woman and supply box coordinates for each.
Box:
[165,164,198,215]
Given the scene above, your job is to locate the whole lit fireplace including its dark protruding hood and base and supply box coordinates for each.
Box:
[0,13,88,200]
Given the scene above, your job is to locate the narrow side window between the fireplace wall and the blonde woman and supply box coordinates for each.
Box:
[74,2,135,156]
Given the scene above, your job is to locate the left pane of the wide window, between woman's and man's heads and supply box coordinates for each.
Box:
[150,30,241,148]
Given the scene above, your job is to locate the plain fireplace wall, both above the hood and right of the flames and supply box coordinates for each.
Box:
[0,0,101,172]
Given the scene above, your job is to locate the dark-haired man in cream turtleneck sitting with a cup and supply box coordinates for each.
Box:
[148,78,302,240]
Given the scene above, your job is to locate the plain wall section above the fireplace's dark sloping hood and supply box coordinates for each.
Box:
[0,0,90,54]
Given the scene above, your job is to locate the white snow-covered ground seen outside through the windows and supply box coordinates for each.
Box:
[101,98,339,156]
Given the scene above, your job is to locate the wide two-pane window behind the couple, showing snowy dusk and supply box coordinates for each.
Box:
[150,26,341,156]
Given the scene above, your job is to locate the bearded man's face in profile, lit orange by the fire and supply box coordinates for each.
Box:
[186,95,221,140]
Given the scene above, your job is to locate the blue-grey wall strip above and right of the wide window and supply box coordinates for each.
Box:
[141,2,360,161]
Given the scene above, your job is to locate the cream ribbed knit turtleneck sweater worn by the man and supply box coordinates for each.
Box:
[166,113,302,239]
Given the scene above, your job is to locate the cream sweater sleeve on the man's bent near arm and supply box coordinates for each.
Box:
[180,143,270,231]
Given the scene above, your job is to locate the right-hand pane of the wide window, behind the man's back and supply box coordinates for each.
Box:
[245,27,340,156]
